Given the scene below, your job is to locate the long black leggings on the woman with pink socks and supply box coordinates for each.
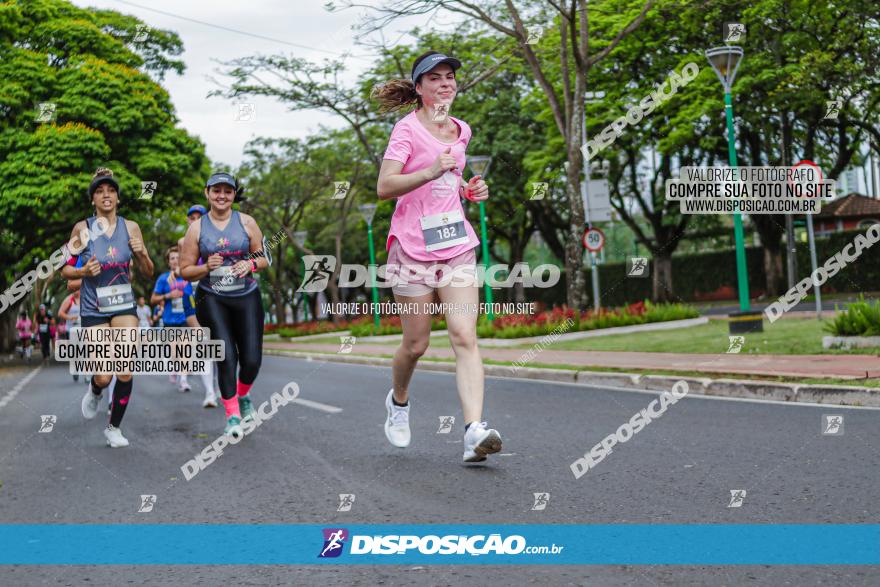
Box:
[196,288,264,399]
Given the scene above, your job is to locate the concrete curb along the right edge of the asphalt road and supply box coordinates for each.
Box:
[263,349,880,407]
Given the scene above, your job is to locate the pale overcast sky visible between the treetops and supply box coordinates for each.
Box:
[73,0,438,166]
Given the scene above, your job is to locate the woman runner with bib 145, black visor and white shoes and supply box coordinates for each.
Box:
[61,167,153,448]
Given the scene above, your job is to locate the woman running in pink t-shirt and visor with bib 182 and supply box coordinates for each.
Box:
[373,51,501,462]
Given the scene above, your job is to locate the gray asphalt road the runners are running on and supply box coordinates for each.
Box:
[0,356,880,586]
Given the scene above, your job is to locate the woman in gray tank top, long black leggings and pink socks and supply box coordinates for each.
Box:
[180,173,269,438]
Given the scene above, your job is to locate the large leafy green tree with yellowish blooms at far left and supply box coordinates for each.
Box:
[0,0,209,350]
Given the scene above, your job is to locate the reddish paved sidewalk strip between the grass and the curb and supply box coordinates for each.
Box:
[264,341,880,379]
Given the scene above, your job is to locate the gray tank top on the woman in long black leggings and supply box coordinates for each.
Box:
[199,210,257,297]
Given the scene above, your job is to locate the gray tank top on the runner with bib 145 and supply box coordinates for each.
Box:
[79,216,134,317]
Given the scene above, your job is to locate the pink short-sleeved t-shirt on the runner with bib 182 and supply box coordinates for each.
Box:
[385,111,480,261]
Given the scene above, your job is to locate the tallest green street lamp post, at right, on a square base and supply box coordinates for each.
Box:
[706,45,762,333]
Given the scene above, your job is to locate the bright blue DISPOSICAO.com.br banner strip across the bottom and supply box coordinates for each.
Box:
[0,524,880,565]
